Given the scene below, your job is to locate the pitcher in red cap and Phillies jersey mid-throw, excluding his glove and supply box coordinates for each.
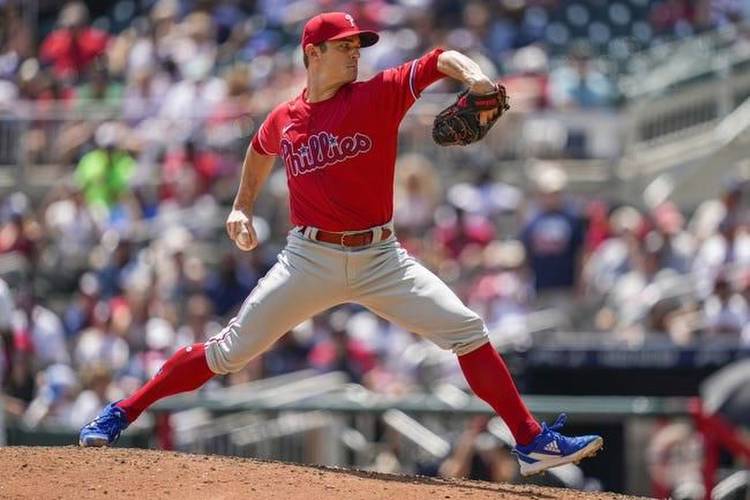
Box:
[80,12,602,475]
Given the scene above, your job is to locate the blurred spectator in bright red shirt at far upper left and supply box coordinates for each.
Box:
[39,2,108,80]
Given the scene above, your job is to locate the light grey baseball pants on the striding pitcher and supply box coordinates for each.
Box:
[206,230,488,374]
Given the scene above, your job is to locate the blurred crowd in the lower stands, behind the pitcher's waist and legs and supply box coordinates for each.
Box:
[0,149,750,432]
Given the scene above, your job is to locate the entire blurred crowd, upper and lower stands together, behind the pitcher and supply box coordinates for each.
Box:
[0,0,750,454]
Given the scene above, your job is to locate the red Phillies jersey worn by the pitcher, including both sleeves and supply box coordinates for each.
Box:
[252,49,445,231]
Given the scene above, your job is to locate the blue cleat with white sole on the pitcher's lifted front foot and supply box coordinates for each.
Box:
[513,413,604,476]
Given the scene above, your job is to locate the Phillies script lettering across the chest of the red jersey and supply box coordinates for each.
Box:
[281,132,372,175]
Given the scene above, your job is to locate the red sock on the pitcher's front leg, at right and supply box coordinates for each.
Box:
[458,342,542,445]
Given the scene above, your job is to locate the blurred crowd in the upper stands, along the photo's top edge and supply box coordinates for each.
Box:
[0,0,747,120]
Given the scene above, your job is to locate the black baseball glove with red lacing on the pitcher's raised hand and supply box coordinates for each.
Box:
[432,83,510,146]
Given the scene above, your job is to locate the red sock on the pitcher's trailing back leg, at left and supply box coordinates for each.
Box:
[117,344,215,422]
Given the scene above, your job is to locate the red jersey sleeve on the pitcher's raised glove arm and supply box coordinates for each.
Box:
[372,49,445,121]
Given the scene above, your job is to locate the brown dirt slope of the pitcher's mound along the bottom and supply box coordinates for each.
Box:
[0,446,648,500]
